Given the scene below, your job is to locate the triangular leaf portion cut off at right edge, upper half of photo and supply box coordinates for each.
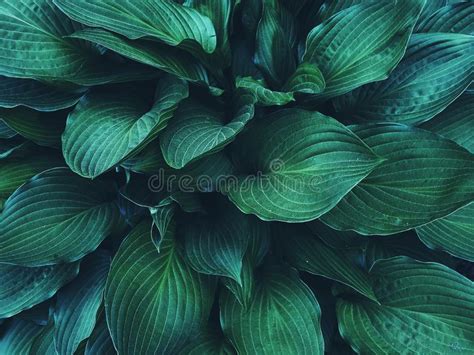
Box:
[420,91,474,154]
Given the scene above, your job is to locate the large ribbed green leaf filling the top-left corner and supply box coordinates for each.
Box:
[0,0,151,85]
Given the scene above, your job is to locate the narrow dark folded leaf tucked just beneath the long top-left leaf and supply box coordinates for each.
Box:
[70,28,209,83]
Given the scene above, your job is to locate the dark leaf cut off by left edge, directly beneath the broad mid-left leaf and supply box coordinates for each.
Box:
[0,263,79,318]
